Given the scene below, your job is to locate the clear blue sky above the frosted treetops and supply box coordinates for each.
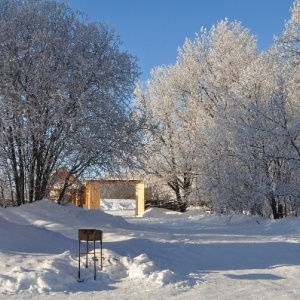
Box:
[68,0,294,81]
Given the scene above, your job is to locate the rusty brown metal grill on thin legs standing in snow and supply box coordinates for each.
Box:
[78,229,103,281]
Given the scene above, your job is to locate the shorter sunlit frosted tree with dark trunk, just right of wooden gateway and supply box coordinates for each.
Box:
[135,67,205,211]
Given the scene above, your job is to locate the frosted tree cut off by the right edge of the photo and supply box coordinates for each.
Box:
[268,0,300,214]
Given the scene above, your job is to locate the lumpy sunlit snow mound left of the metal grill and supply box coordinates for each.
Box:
[0,251,75,295]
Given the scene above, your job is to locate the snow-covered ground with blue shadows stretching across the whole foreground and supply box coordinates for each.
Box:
[0,200,300,300]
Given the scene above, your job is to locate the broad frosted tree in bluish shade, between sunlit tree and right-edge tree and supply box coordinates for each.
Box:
[206,55,292,216]
